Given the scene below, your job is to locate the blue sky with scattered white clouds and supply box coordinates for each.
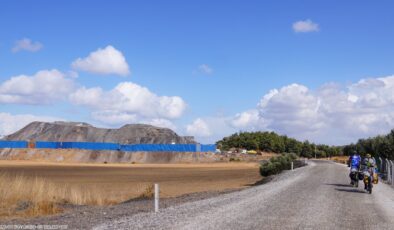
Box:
[0,0,394,145]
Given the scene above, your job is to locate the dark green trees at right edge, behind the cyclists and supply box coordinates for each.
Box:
[343,129,394,159]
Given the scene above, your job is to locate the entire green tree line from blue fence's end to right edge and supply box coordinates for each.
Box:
[216,129,394,159]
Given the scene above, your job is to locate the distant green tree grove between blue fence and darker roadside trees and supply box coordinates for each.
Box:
[216,132,342,157]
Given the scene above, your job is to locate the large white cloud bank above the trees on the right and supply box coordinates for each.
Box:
[231,76,394,144]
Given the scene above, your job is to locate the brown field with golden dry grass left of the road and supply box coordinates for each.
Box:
[0,161,261,217]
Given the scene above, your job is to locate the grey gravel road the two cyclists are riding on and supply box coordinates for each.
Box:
[96,161,394,229]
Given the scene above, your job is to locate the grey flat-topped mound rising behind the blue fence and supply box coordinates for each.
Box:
[3,121,196,144]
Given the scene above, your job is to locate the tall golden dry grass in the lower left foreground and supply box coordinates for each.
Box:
[0,173,152,217]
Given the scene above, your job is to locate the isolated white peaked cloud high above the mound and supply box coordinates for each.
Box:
[71,45,130,76]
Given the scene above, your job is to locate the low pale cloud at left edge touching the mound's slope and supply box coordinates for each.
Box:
[0,113,63,136]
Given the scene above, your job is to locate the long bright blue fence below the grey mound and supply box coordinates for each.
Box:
[0,141,216,152]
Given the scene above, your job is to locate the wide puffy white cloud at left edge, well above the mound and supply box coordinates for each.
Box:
[0,69,75,104]
